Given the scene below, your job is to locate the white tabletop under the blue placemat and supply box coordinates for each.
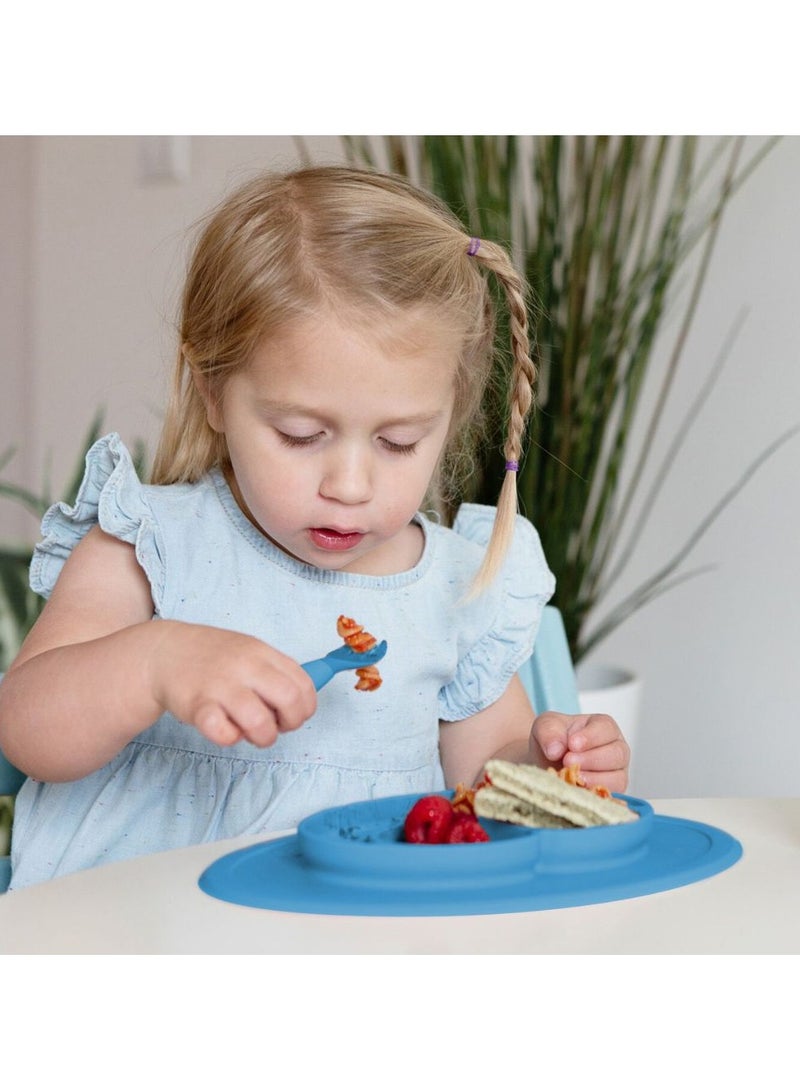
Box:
[0,799,800,955]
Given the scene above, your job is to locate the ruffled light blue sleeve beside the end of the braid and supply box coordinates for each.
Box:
[439,504,556,721]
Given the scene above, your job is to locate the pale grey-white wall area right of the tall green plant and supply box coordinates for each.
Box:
[594,137,800,795]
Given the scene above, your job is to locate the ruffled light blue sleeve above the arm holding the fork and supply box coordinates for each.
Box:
[31,432,165,612]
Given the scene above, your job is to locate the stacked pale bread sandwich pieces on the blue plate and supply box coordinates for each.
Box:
[474,758,638,829]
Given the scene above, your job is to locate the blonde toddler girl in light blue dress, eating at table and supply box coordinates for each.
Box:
[0,167,629,887]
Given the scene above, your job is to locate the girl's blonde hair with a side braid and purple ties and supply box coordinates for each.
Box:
[152,167,535,589]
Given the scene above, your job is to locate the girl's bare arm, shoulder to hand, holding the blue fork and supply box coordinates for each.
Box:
[0,528,317,780]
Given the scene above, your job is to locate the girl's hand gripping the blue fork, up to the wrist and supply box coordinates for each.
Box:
[148,621,317,746]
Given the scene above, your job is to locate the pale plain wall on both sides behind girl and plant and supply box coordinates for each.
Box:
[0,136,800,798]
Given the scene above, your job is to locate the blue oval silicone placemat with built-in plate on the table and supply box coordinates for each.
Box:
[200,793,742,916]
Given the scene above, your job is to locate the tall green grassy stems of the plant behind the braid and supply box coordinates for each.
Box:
[333,136,798,662]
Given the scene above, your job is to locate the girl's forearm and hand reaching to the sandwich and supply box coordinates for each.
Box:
[439,675,631,792]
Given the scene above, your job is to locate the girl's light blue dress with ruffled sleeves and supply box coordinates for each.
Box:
[7,434,553,888]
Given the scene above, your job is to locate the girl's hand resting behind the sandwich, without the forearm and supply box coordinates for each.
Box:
[530,712,631,792]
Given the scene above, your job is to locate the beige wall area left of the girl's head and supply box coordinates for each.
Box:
[0,136,341,528]
